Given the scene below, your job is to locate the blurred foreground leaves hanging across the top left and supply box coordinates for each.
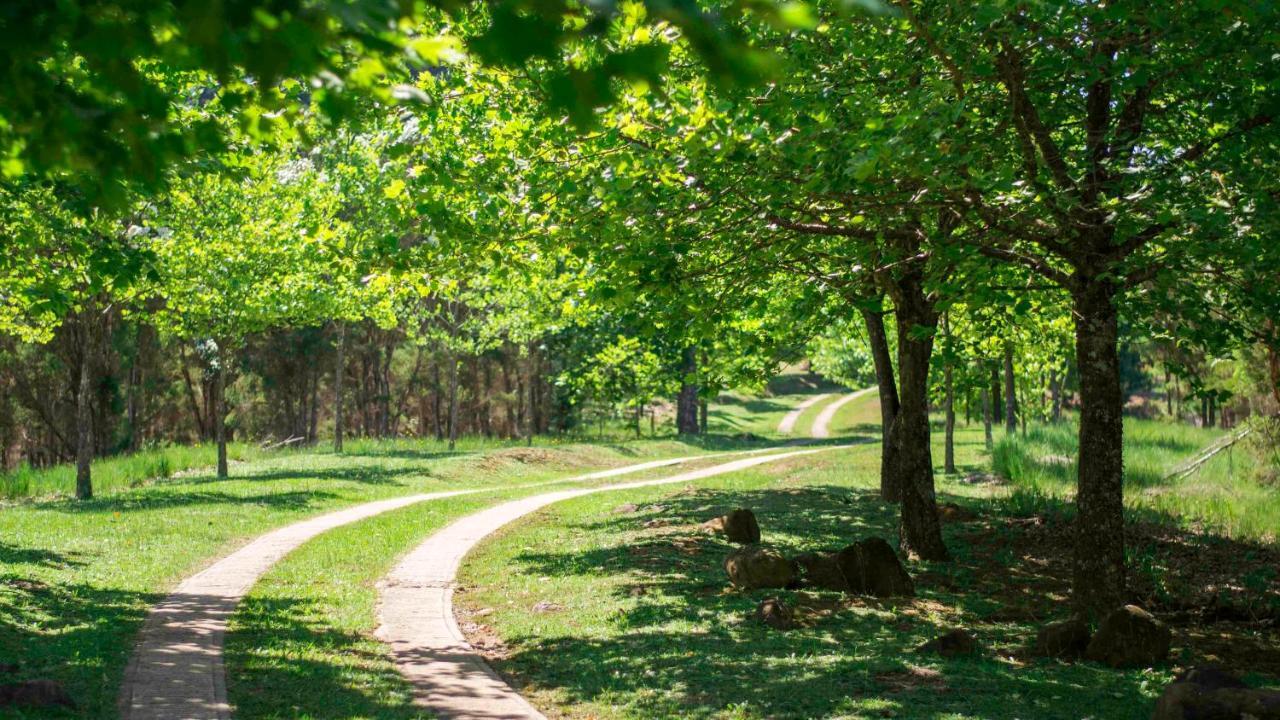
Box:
[0,0,874,193]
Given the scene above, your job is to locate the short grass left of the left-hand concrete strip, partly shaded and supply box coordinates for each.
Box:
[0,441,727,719]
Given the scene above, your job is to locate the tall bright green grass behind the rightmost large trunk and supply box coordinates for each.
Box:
[993,418,1280,542]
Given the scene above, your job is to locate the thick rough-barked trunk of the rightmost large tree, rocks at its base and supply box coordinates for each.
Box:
[1073,279,1125,618]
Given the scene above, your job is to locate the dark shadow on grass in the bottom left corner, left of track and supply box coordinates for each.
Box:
[0,571,160,719]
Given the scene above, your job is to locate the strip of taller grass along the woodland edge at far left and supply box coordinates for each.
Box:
[0,442,265,500]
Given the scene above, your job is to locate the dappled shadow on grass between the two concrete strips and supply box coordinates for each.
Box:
[225,596,430,720]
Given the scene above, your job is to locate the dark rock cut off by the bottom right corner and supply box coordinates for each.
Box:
[1151,667,1280,720]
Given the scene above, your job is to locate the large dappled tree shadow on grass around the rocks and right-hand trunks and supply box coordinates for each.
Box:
[471,486,1280,720]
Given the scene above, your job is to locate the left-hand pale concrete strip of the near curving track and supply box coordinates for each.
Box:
[119,455,714,720]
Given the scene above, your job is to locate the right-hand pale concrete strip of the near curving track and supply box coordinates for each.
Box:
[378,447,831,720]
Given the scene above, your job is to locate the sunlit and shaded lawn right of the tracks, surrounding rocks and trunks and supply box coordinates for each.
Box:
[457,398,1280,720]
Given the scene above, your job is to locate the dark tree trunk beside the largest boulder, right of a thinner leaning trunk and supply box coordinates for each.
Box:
[890,288,950,560]
